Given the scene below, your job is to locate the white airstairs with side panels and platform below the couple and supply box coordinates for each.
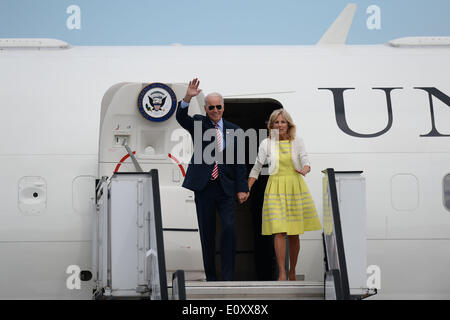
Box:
[93,169,376,300]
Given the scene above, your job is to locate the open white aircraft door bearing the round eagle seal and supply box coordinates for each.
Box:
[94,82,204,280]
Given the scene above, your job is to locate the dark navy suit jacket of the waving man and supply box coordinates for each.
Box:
[176,103,248,196]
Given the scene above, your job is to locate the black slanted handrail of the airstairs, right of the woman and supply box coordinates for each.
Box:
[326,168,350,300]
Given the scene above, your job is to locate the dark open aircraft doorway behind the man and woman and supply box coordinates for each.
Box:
[216,98,283,281]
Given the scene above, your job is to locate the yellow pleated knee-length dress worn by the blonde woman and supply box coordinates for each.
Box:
[262,140,322,235]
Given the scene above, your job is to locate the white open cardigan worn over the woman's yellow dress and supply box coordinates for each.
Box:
[249,137,310,179]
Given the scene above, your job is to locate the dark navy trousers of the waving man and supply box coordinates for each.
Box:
[195,179,236,281]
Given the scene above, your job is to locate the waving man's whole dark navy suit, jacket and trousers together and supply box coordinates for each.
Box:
[176,102,248,281]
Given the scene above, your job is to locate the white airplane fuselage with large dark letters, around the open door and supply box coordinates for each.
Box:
[0,45,450,299]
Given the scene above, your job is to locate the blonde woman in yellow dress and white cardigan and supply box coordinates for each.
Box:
[248,109,322,280]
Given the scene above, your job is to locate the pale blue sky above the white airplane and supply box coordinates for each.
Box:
[0,0,450,45]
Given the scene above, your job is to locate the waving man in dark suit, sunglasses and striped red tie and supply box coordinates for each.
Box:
[176,79,248,281]
